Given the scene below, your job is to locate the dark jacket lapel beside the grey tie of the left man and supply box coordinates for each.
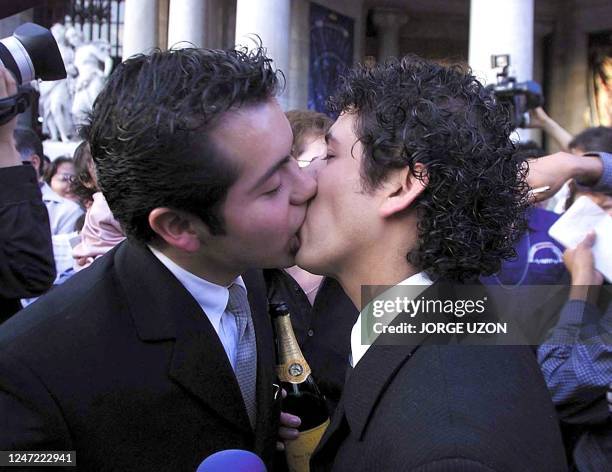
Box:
[115,241,251,432]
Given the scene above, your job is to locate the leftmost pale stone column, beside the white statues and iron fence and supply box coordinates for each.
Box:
[123,0,157,60]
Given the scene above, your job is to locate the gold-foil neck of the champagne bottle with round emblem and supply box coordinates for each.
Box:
[274,315,311,384]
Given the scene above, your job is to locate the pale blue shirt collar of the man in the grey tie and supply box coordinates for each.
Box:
[149,246,247,332]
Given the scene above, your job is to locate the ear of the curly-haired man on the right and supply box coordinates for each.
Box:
[379,163,428,218]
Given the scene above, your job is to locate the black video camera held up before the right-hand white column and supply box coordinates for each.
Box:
[487,54,544,128]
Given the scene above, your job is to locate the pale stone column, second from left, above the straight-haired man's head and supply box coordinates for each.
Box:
[168,0,207,48]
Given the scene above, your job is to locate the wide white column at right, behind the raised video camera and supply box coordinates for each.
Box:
[469,0,535,141]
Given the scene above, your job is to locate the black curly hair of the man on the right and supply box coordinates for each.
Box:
[330,56,528,281]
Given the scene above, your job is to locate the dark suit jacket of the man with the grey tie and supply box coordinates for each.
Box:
[0,242,279,472]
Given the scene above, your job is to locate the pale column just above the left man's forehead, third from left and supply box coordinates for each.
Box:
[236,0,291,109]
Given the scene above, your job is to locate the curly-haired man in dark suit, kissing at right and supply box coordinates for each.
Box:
[296,56,566,471]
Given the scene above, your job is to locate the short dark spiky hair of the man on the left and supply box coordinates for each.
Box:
[82,48,283,242]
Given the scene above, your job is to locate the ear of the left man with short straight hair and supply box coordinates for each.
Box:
[149,207,205,252]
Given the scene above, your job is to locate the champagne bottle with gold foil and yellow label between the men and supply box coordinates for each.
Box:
[270,303,329,472]
